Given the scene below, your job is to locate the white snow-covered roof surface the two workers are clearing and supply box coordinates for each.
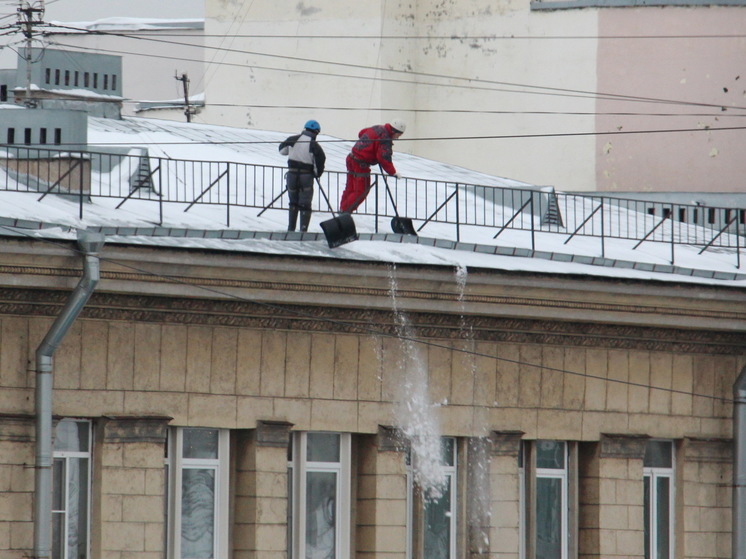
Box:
[0,117,746,287]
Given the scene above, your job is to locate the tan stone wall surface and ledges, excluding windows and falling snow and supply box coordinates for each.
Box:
[0,242,746,559]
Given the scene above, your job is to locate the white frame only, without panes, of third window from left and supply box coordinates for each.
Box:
[287,431,352,559]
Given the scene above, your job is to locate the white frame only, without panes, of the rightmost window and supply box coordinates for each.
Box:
[642,439,676,559]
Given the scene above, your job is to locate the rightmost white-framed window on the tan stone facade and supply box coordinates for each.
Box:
[643,440,674,559]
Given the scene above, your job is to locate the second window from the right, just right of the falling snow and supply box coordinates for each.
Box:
[519,440,576,559]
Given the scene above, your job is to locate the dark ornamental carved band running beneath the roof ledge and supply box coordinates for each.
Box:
[0,286,746,355]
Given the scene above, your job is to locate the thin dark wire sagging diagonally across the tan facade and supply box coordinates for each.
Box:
[0,225,734,404]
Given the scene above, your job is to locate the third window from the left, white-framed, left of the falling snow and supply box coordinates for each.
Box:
[288,432,350,559]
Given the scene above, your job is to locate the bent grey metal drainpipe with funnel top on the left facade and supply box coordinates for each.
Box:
[33,230,104,559]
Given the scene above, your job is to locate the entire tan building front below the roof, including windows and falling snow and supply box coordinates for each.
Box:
[0,237,746,559]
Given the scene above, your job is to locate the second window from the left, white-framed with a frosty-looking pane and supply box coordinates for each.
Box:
[166,427,229,559]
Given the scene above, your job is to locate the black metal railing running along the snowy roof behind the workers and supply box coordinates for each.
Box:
[0,145,746,268]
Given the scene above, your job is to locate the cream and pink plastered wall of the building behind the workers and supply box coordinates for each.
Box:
[200,0,746,192]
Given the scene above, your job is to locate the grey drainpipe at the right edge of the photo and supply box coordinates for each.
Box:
[733,367,746,559]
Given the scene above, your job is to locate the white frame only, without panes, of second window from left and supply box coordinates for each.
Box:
[165,427,230,559]
